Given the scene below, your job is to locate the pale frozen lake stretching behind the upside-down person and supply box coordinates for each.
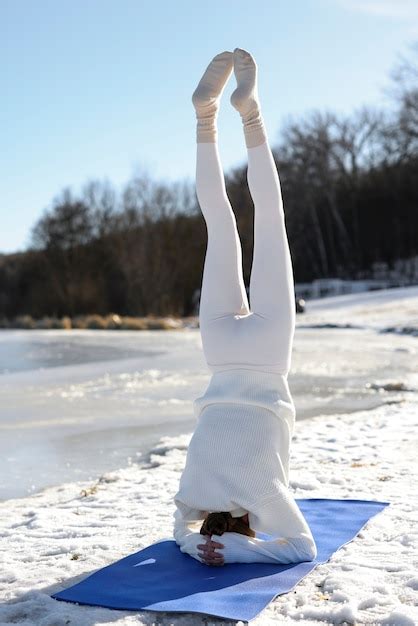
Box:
[0,290,418,500]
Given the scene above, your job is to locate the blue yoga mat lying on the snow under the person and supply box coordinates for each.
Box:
[51,498,389,621]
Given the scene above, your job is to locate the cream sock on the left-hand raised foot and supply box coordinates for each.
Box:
[192,50,234,143]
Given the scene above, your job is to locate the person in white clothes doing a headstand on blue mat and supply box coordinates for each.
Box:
[173,48,317,565]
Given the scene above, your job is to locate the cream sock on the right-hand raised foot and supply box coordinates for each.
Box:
[231,48,267,148]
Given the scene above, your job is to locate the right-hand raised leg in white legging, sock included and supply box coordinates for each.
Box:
[231,48,296,370]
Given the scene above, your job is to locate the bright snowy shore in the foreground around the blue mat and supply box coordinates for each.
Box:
[0,393,418,626]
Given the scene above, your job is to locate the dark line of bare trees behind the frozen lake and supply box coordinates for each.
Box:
[0,42,418,318]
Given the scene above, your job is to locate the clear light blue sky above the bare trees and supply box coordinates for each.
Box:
[0,0,418,252]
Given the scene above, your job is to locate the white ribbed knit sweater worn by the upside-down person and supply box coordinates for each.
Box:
[174,367,316,563]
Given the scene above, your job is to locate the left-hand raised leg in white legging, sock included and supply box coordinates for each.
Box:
[192,52,249,363]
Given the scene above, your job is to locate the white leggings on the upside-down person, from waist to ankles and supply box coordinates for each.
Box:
[196,141,296,376]
